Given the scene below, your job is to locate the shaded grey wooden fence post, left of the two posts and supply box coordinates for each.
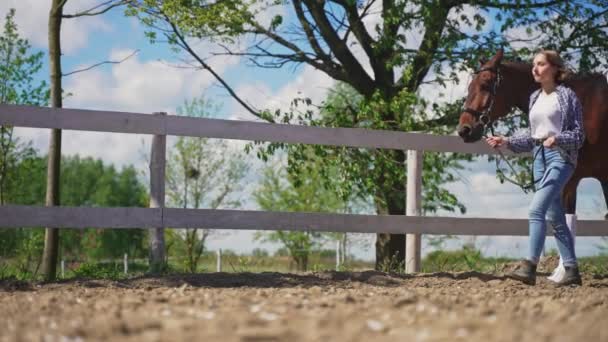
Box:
[149,112,167,273]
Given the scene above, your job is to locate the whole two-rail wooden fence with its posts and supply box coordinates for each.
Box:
[0,104,608,272]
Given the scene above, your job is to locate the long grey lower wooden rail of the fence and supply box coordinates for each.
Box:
[0,205,608,236]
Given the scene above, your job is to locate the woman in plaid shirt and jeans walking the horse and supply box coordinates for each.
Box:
[486,50,585,286]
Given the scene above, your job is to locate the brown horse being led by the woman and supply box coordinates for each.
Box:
[458,50,608,219]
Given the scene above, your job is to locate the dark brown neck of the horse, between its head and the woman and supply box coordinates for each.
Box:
[504,63,538,113]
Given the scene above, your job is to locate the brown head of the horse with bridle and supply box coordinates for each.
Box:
[458,50,506,142]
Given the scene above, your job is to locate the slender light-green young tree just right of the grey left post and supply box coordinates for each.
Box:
[166,97,247,273]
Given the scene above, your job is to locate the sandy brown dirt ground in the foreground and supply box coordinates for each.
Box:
[0,271,608,342]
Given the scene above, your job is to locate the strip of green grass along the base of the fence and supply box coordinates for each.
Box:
[0,247,608,280]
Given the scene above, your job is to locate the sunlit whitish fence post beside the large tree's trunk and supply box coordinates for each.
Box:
[405,150,423,273]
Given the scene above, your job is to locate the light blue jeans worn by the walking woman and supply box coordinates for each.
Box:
[528,146,577,266]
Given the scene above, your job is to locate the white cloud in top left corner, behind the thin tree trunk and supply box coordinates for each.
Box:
[0,0,112,55]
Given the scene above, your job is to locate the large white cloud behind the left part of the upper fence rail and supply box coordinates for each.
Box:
[17,44,242,169]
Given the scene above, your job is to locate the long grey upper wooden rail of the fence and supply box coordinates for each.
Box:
[0,105,513,155]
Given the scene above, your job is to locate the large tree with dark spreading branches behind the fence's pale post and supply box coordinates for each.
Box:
[130,0,608,267]
